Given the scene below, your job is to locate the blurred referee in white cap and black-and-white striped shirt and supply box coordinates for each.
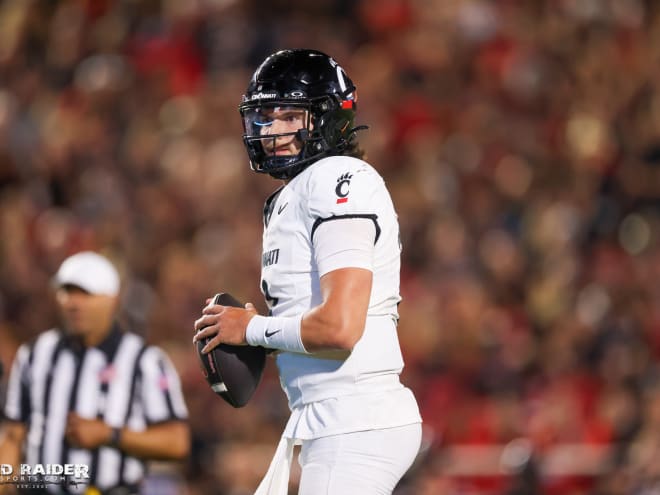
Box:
[0,251,190,495]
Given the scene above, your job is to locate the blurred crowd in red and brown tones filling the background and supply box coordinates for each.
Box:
[0,0,660,495]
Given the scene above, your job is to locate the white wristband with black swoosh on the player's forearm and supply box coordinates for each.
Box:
[245,315,307,354]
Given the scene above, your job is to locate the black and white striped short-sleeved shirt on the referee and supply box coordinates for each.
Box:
[5,326,188,493]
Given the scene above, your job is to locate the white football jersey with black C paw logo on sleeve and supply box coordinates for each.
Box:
[261,156,419,438]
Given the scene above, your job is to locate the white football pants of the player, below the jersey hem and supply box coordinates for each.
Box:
[298,423,422,495]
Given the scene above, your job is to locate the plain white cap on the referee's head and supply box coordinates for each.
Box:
[54,251,119,296]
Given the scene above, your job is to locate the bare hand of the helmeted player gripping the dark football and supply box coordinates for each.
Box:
[193,303,257,353]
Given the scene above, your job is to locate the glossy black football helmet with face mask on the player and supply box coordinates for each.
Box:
[239,49,364,179]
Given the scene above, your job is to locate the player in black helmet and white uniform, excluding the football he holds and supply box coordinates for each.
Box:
[195,49,421,495]
